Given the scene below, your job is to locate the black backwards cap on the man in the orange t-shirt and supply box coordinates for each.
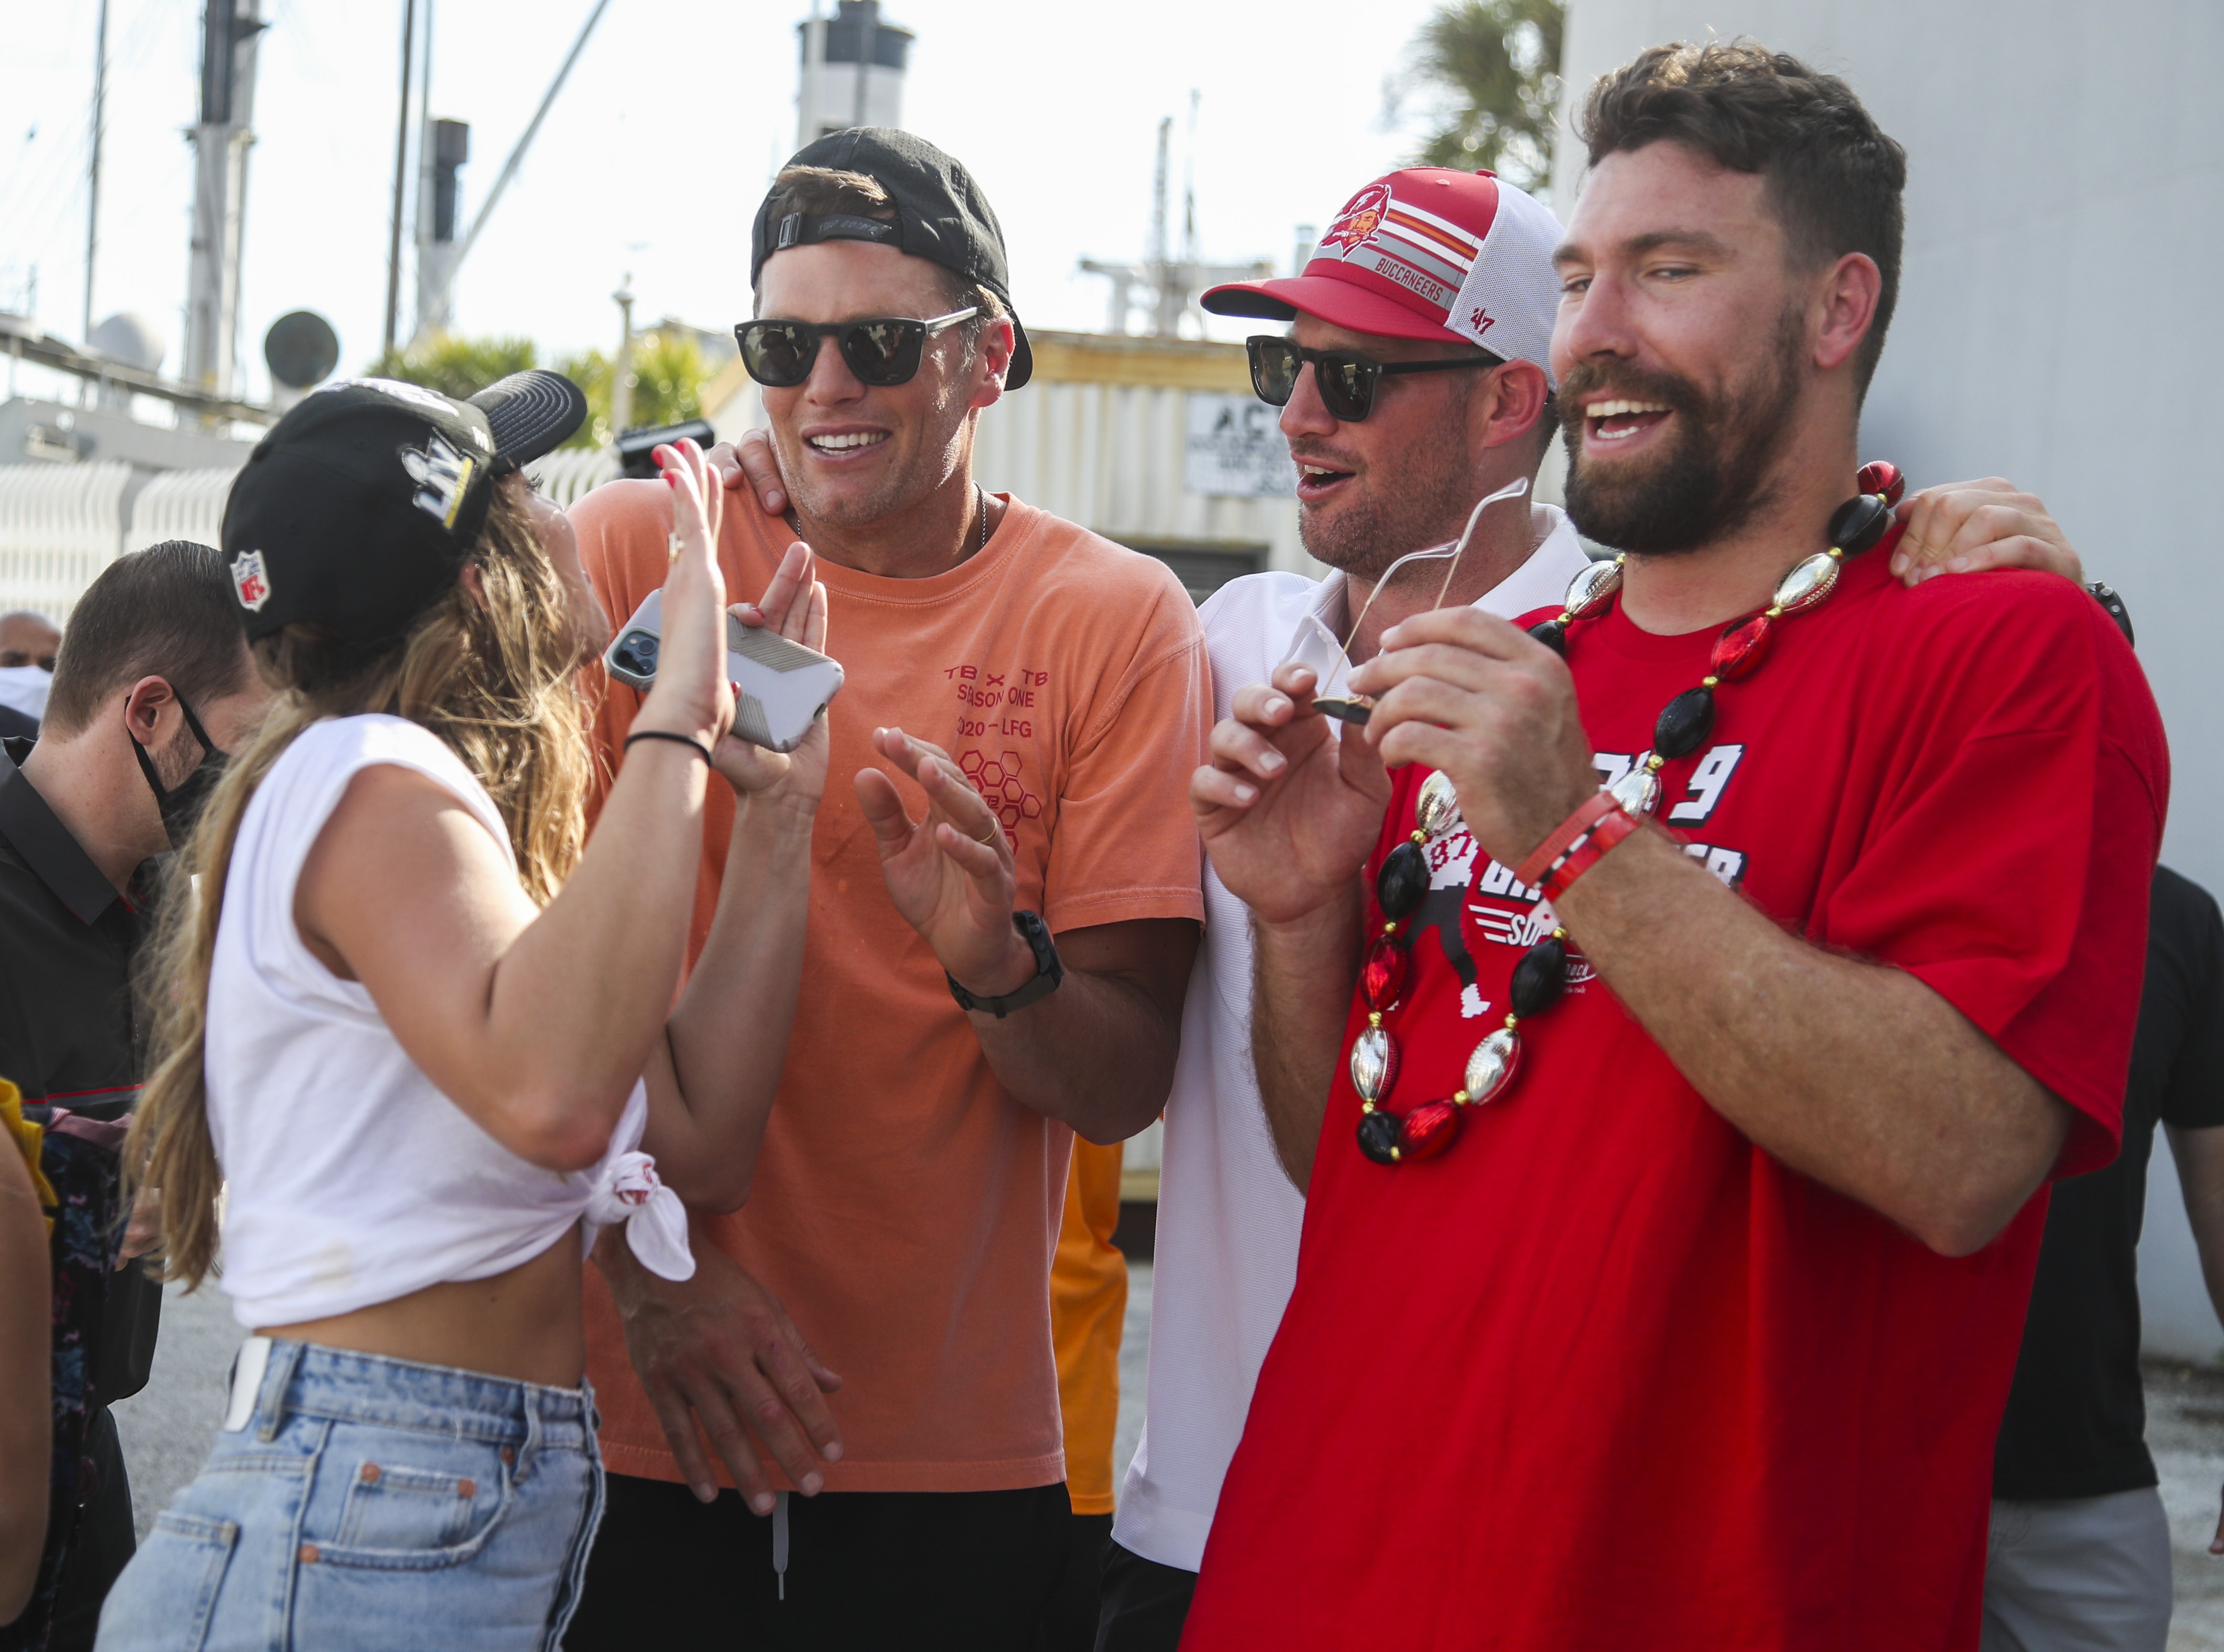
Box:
[750,127,1034,389]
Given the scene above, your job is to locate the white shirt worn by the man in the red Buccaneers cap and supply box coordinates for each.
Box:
[1112,505,1585,1572]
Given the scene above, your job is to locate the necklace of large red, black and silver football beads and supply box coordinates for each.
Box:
[1350,460,1906,1165]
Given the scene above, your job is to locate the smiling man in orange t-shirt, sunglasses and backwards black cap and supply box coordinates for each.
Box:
[565,129,1210,1648]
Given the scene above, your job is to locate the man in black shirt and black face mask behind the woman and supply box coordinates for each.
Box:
[0,540,264,1648]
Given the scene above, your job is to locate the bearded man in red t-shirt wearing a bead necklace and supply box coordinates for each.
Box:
[1183,42,2168,1652]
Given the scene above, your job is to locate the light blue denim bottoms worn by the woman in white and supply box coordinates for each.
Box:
[100,1341,603,1652]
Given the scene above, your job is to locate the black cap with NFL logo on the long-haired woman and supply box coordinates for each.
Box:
[222,369,587,645]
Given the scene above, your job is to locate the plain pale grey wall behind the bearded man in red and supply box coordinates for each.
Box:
[1555,0,2224,1359]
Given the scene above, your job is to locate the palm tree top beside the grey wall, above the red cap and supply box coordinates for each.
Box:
[1384,0,1563,194]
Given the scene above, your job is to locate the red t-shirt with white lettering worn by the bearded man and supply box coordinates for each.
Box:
[1183,556,2168,1652]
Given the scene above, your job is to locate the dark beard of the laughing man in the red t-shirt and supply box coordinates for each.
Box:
[1561,316,1802,556]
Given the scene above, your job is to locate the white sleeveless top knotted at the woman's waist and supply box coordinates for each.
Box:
[205,716,694,1329]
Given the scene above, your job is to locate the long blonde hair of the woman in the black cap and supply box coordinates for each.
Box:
[124,487,592,1287]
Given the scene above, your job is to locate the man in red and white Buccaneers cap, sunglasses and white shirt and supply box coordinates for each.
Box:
[1097,167,1585,1652]
